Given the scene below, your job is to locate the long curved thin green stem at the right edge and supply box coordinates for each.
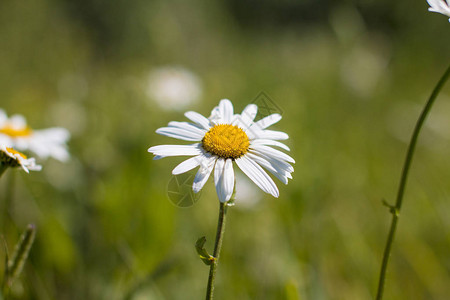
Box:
[376,66,450,300]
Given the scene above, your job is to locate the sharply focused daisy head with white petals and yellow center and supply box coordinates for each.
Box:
[148,99,295,202]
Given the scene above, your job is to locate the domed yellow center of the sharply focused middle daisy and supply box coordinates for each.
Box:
[202,124,250,158]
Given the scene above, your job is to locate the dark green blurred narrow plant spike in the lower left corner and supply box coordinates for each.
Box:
[7,224,36,286]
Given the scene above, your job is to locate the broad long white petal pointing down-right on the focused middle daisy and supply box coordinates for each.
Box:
[235,156,280,198]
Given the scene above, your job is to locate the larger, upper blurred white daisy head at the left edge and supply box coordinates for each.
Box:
[0,109,70,161]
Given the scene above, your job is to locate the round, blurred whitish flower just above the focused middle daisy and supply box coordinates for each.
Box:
[146,67,202,111]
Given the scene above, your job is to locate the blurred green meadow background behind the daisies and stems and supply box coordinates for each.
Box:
[0,0,450,299]
